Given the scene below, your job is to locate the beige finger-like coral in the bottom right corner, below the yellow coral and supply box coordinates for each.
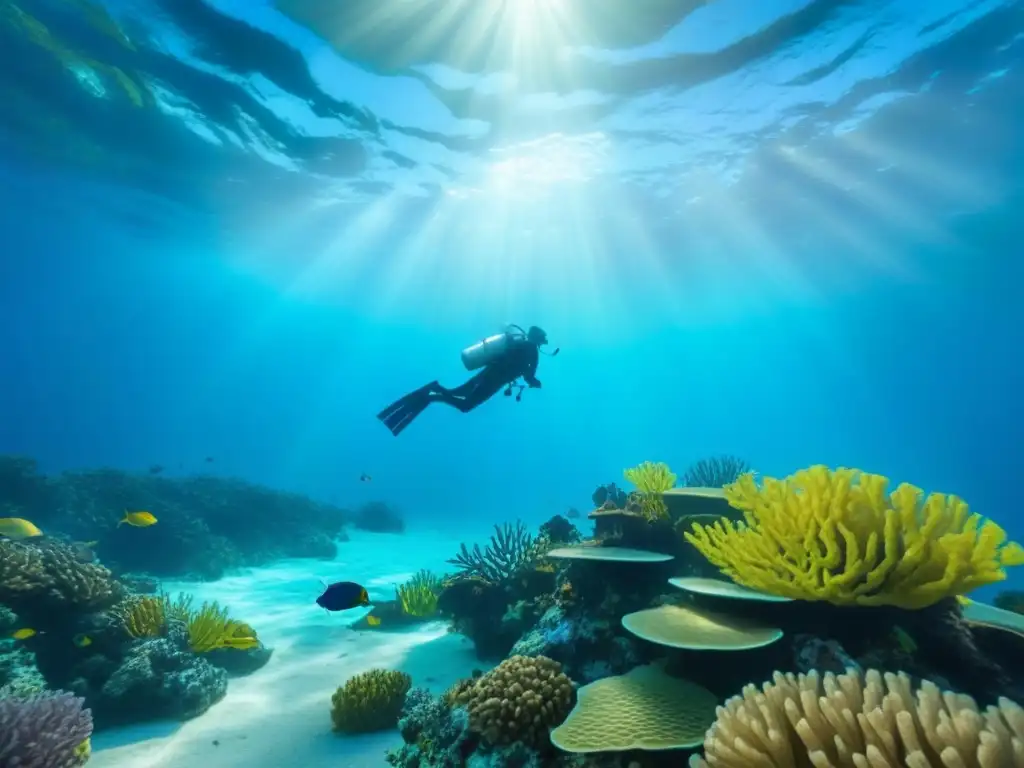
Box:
[690,670,1024,768]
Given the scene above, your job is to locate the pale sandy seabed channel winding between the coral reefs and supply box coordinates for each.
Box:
[89,531,482,768]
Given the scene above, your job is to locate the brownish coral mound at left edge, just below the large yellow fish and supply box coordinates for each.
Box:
[0,539,123,614]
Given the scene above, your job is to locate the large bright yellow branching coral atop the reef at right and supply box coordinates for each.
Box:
[685,466,1024,608]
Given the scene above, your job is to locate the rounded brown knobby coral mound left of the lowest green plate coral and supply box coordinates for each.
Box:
[454,656,572,748]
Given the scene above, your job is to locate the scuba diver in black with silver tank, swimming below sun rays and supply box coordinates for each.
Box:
[377,326,560,437]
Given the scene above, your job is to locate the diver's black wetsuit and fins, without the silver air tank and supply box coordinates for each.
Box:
[377,337,541,436]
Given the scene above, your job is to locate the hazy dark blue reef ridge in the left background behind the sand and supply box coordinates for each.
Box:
[0,457,347,579]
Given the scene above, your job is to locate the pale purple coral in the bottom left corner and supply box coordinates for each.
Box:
[0,693,92,768]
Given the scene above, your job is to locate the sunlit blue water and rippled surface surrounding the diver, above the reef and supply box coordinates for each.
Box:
[0,0,1024,552]
